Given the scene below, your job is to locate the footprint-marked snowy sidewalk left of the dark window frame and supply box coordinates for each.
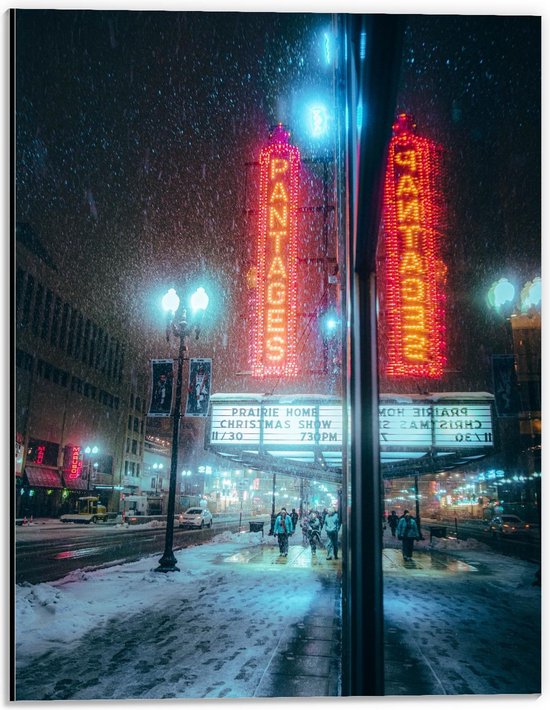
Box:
[16,533,339,700]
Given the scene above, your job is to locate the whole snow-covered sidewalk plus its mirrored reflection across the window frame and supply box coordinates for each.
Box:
[16,533,541,700]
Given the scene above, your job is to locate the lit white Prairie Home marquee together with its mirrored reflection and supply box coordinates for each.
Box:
[206,392,494,482]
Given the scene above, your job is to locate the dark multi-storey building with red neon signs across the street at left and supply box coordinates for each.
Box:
[13,224,146,517]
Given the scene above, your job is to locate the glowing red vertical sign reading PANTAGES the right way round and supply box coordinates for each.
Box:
[252,124,300,377]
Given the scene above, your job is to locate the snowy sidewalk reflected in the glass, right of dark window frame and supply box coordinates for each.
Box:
[384,538,541,695]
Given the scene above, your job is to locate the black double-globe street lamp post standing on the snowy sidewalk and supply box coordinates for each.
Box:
[156,286,209,572]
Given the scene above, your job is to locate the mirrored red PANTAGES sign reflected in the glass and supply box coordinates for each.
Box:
[381,114,446,379]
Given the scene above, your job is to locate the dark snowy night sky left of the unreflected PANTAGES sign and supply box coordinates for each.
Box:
[16,11,334,372]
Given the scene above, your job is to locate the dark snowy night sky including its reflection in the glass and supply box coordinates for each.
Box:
[15,10,541,392]
